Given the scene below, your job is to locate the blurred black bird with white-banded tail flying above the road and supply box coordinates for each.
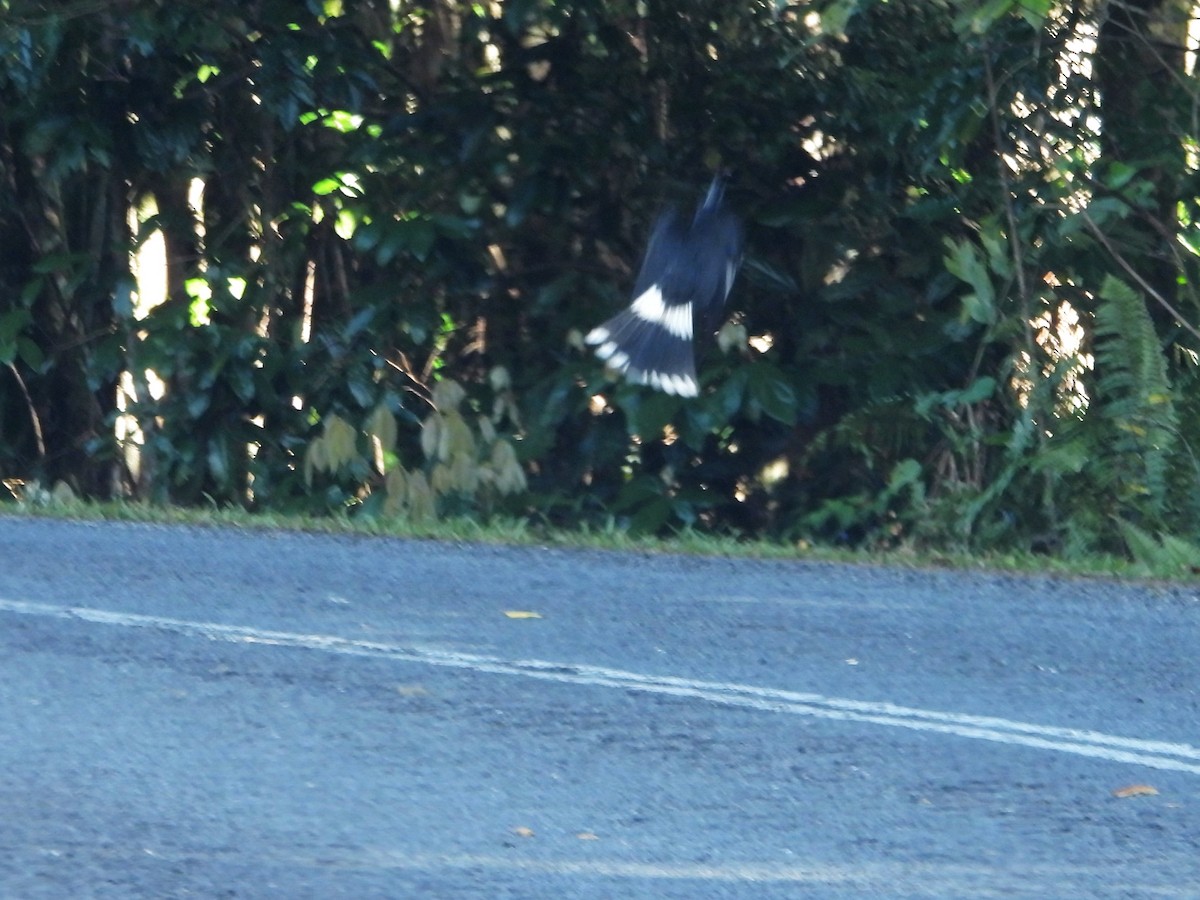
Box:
[584,174,742,397]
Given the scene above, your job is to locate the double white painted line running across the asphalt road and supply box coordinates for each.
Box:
[9,599,1200,775]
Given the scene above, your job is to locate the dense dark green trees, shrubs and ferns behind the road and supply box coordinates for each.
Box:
[0,0,1200,564]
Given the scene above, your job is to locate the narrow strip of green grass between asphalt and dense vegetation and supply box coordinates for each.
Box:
[0,493,1200,582]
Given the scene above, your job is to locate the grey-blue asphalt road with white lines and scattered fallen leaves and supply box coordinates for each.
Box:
[0,518,1200,900]
